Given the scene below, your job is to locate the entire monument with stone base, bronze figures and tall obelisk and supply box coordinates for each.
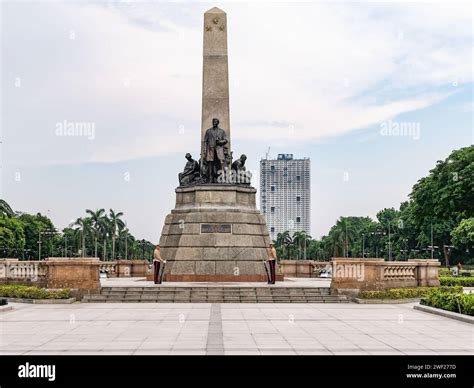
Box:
[160,8,271,282]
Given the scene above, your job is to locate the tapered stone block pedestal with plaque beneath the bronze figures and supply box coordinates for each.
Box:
[160,184,271,282]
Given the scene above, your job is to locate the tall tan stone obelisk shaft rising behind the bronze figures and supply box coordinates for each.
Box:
[201,7,232,155]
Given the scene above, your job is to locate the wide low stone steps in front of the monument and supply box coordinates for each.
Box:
[82,286,349,303]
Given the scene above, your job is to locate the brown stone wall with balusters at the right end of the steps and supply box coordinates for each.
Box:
[331,258,440,295]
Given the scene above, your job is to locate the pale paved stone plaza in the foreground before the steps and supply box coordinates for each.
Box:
[0,303,474,355]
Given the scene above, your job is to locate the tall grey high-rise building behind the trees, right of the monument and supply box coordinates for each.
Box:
[260,154,311,240]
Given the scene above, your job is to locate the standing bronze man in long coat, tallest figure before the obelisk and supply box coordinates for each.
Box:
[202,118,228,183]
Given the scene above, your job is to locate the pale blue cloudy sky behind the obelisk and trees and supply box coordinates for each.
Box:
[0,1,474,242]
